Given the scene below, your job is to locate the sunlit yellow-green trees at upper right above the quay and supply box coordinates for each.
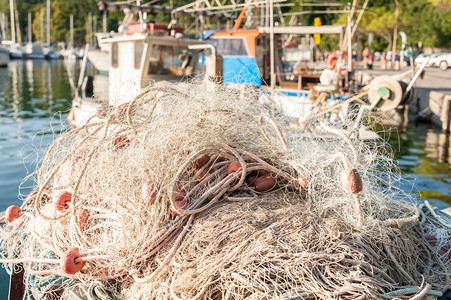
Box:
[291,0,451,51]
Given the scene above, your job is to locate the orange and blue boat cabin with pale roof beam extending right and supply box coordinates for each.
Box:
[206,25,346,89]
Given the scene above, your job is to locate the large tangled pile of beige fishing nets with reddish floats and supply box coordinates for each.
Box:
[0,83,451,299]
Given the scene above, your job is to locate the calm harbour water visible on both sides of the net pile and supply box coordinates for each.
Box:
[0,60,451,299]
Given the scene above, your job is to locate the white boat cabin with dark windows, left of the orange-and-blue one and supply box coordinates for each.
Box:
[105,34,209,105]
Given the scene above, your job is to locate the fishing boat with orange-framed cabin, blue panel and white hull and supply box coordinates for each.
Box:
[205,25,351,121]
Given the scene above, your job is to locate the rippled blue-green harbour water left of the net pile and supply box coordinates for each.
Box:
[0,60,76,210]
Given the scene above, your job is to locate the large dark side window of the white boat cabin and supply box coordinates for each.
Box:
[147,45,190,76]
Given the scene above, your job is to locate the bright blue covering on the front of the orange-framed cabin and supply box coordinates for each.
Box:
[223,56,262,86]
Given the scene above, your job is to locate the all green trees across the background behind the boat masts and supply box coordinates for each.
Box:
[0,0,451,51]
